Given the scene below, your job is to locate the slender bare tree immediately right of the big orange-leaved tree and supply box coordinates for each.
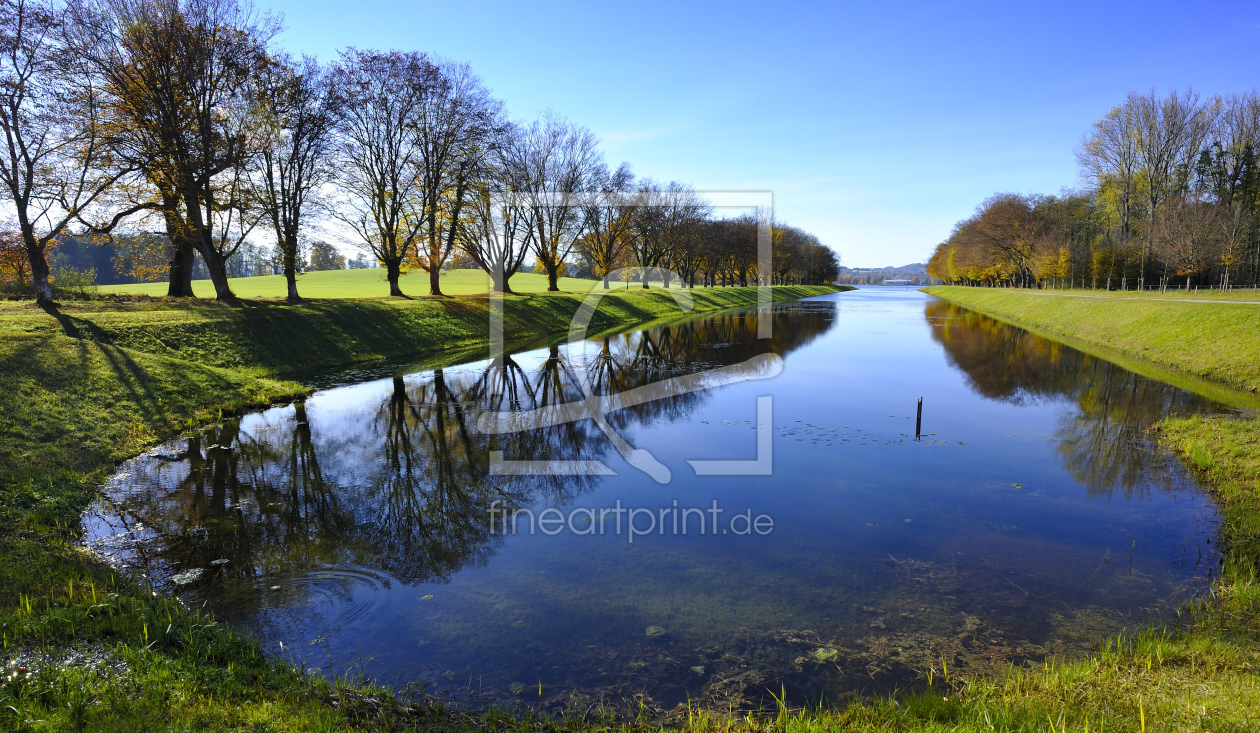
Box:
[255,55,336,301]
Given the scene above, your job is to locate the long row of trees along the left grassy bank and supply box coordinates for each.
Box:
[0,0,835,301]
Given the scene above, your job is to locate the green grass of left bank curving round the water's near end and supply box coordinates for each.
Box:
[17,279,1260,733]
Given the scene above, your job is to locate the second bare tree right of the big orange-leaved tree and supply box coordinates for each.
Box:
[329,48,442,296]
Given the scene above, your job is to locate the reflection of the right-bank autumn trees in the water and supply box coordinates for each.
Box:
[926,300,1229,497]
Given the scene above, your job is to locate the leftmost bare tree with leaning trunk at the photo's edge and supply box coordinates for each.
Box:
[0,0,139,305]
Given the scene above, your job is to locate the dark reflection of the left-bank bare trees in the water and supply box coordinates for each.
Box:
[96,304,832,618]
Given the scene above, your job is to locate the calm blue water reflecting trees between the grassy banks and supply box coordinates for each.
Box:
[87,290,1226,708]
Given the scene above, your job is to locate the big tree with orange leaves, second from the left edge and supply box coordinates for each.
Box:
[69,0,278,300]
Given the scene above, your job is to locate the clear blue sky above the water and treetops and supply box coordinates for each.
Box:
[258,0,1260,267]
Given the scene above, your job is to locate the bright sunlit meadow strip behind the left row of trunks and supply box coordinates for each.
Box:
[97,267,609,298]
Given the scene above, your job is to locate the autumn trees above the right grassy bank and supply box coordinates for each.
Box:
[929,89,1260,288]
